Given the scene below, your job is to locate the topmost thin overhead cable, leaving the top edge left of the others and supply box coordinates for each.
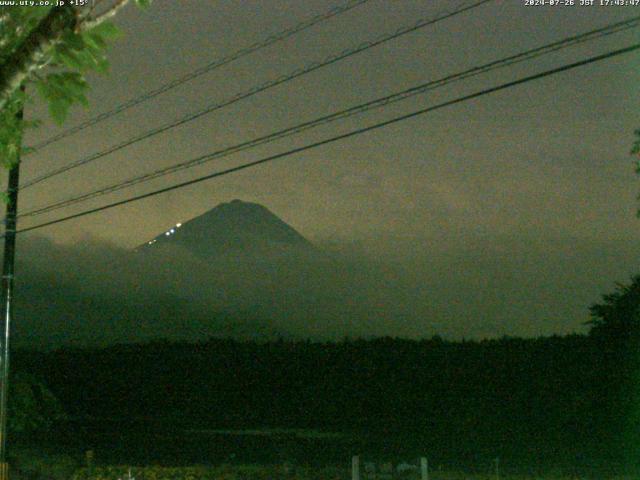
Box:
[26,0,376,153]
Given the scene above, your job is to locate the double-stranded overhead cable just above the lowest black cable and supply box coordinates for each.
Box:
[20,15,640,217]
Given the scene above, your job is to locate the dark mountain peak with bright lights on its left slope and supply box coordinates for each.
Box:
[136,200,314,257]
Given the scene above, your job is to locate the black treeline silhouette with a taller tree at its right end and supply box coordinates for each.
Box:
[8,279,640,471]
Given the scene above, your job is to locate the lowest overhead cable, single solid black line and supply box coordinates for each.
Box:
[11,43,640,233]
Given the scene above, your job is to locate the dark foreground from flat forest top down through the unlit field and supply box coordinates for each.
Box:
[8,326,640,480]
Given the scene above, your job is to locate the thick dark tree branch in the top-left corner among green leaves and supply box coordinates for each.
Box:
[0,5,77,110]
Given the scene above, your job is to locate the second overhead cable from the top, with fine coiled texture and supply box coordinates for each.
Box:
[20,0,493,190]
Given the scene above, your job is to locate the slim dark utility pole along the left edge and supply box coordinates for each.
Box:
[0,86,24,480]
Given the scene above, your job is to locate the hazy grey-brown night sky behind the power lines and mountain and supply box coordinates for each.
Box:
[5,0,640,344]
